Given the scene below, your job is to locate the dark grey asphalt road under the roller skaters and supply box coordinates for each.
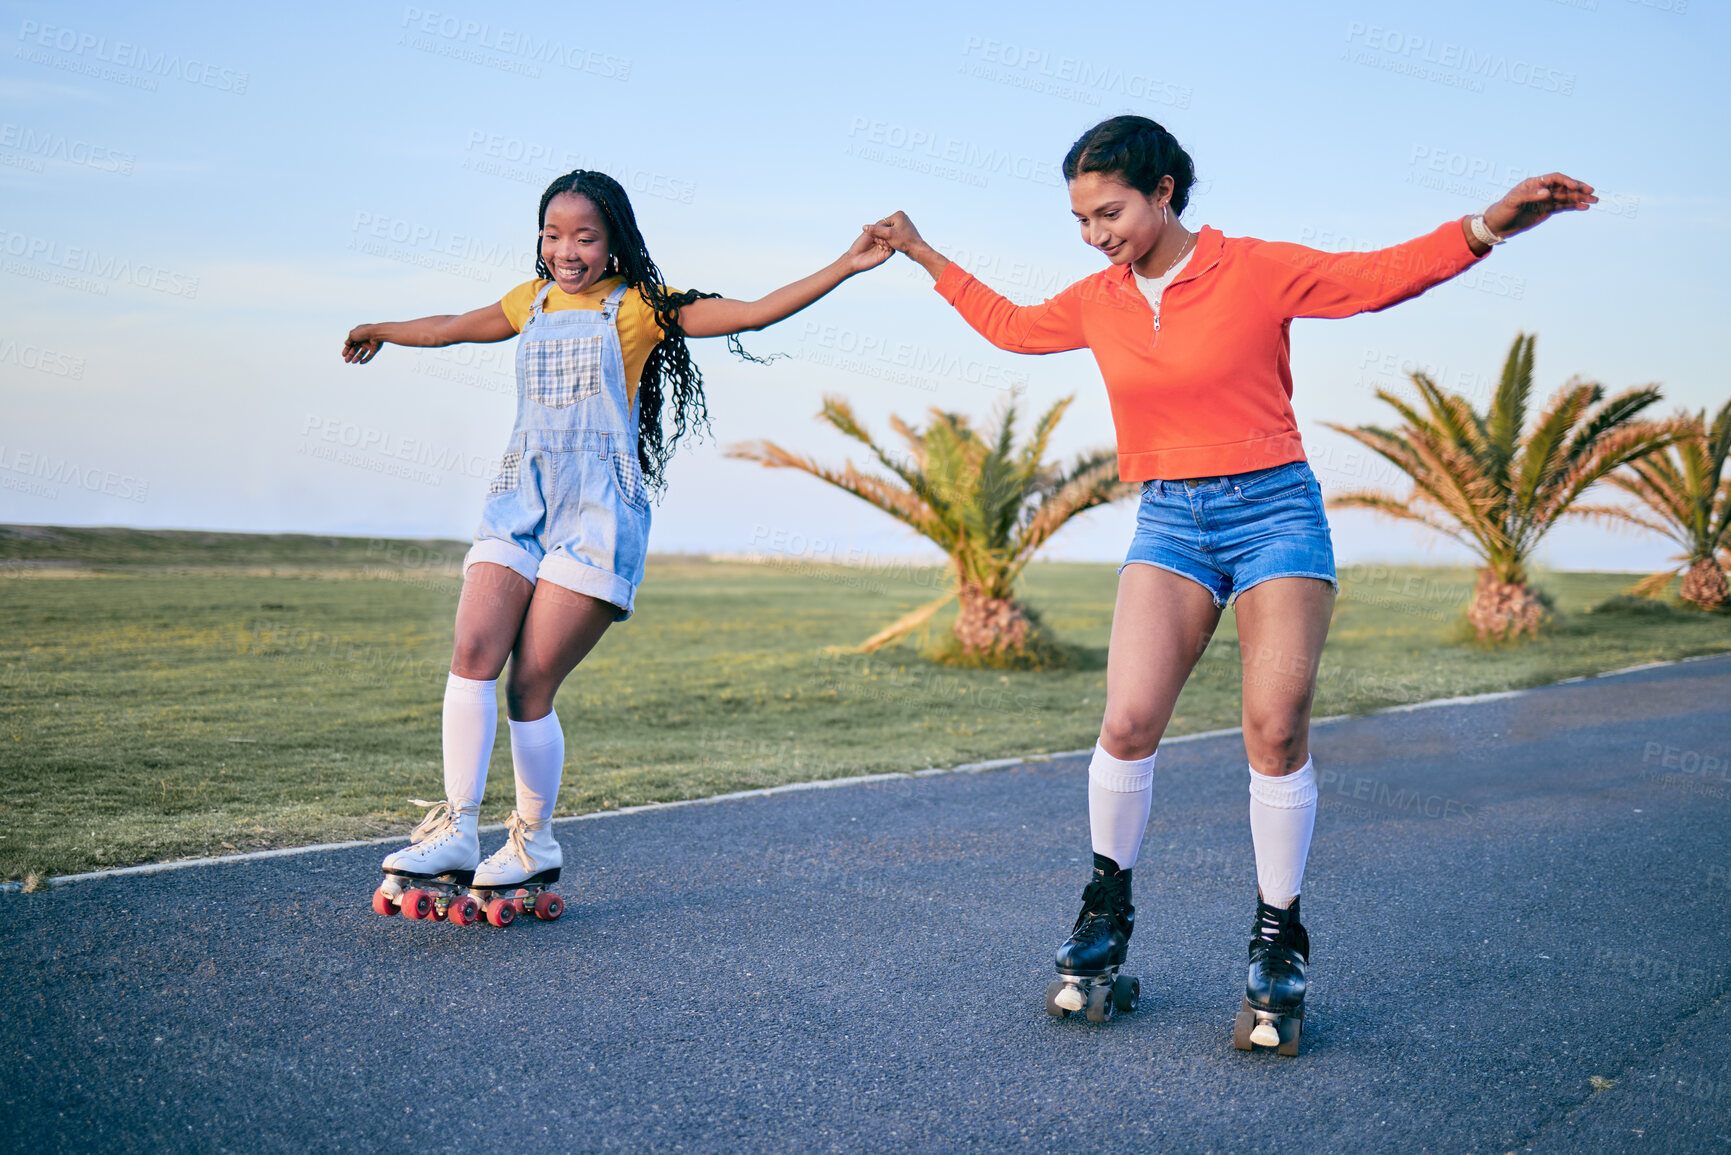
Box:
[0,658,1731,1155]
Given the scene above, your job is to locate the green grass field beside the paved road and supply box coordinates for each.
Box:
[0,526,1731,880]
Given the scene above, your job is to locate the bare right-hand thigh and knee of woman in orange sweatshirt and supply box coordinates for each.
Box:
[1234,577,1335,778]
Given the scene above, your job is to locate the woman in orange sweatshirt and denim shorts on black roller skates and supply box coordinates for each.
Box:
[872,116,1596,1055]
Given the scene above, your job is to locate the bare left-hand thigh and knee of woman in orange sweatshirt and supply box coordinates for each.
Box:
[1099,565,1220,762]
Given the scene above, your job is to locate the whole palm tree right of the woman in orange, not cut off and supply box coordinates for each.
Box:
[1328,334,1681,639]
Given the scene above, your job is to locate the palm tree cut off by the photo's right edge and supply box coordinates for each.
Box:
[1579,402,1731,610]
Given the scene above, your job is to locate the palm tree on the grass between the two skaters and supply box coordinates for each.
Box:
[727,397,1134,667]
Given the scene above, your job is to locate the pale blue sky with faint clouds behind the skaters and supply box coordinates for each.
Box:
[0,0,1731,570]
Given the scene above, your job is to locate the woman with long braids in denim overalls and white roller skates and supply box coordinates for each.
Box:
[343,170,890,925]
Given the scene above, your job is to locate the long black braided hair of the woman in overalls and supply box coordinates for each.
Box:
[535,168,720,494]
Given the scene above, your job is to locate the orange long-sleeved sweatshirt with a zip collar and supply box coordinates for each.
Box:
[936,220,1478,481]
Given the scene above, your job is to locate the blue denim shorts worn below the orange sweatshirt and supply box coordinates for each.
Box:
[1118,461,1340,606]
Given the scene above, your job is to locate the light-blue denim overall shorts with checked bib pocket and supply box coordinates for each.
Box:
[462,284,649,620]
